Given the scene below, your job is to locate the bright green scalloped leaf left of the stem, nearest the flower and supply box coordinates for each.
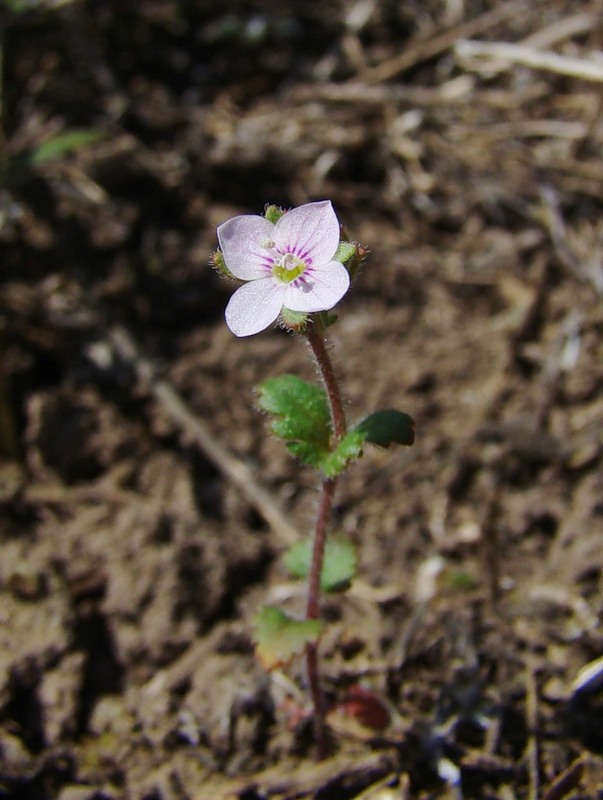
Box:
[258,375,331,458]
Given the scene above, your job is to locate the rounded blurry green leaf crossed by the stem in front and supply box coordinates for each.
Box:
[284,536,358,592]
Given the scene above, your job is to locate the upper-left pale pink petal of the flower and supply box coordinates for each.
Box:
[218,214,274,281]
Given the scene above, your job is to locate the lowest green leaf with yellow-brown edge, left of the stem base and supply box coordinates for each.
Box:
[254,606,325,671]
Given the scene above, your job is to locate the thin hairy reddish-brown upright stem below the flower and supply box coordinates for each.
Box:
[306,320,347,759]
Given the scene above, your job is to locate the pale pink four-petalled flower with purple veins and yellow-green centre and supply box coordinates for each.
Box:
[218,200,350,336]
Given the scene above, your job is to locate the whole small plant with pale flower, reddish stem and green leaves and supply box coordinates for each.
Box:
[213,200,414,756]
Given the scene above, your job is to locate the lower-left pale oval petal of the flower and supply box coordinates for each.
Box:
[225,278,287,336]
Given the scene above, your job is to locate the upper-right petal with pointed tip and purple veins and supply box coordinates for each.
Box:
[274,200,339,266]
